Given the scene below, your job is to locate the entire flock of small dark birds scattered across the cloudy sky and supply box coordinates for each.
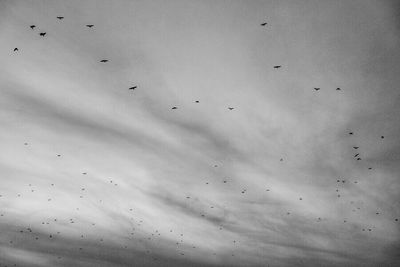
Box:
[0,16,398,266]
